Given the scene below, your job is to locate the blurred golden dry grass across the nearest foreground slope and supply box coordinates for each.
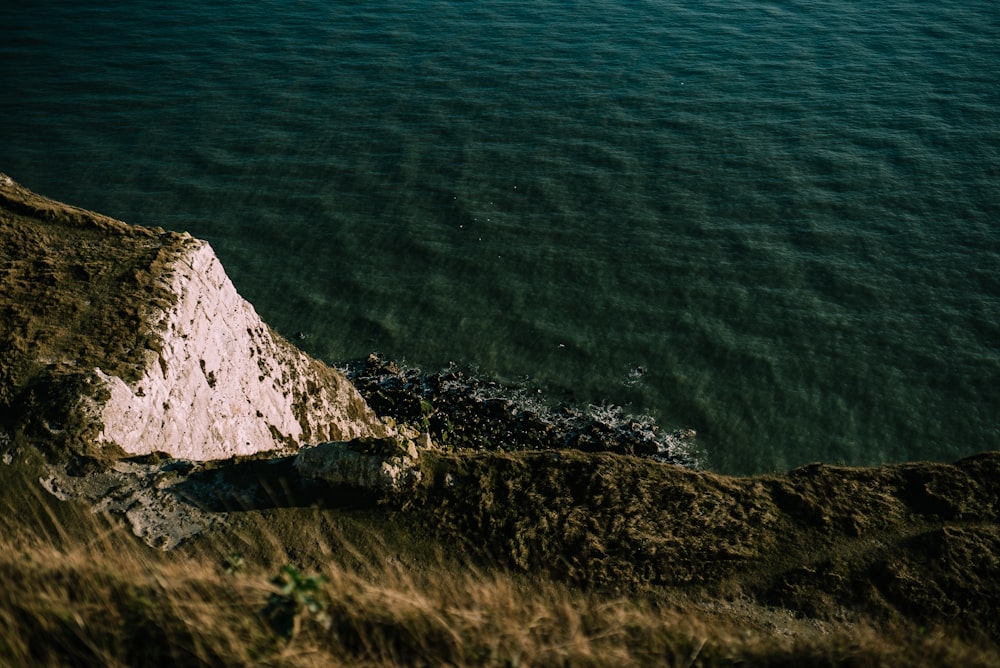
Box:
[0,464,997,666]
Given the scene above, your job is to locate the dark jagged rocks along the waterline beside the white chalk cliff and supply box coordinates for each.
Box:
[346,355,699,468]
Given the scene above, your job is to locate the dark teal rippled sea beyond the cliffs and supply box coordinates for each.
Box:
[0,0,1000,473]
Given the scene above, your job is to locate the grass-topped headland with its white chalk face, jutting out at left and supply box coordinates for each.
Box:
[0,175,387,460]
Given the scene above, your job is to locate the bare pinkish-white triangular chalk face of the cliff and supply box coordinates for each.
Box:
[88,240,385,460]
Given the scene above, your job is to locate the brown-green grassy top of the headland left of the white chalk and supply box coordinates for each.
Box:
[0,174,195,456]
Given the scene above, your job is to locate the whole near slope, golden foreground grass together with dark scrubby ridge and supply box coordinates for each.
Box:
[0,444,1000,666]
